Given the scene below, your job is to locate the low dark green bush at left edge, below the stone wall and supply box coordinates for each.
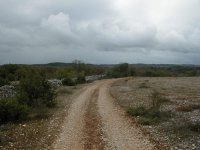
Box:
[0,98,29,123]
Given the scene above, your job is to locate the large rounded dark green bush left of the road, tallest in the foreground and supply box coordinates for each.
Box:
[17,72,56,107]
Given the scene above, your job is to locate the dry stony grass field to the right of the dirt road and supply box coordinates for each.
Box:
[110,77,200,150]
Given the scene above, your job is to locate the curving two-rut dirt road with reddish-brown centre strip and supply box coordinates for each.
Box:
[53,80,154,150]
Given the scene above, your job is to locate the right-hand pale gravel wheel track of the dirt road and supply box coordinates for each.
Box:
[98,80,154,150]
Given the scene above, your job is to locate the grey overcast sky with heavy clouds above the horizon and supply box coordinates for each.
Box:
[0,0,200,64]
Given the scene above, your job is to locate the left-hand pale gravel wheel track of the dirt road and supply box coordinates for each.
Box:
[54,86,96,150]
